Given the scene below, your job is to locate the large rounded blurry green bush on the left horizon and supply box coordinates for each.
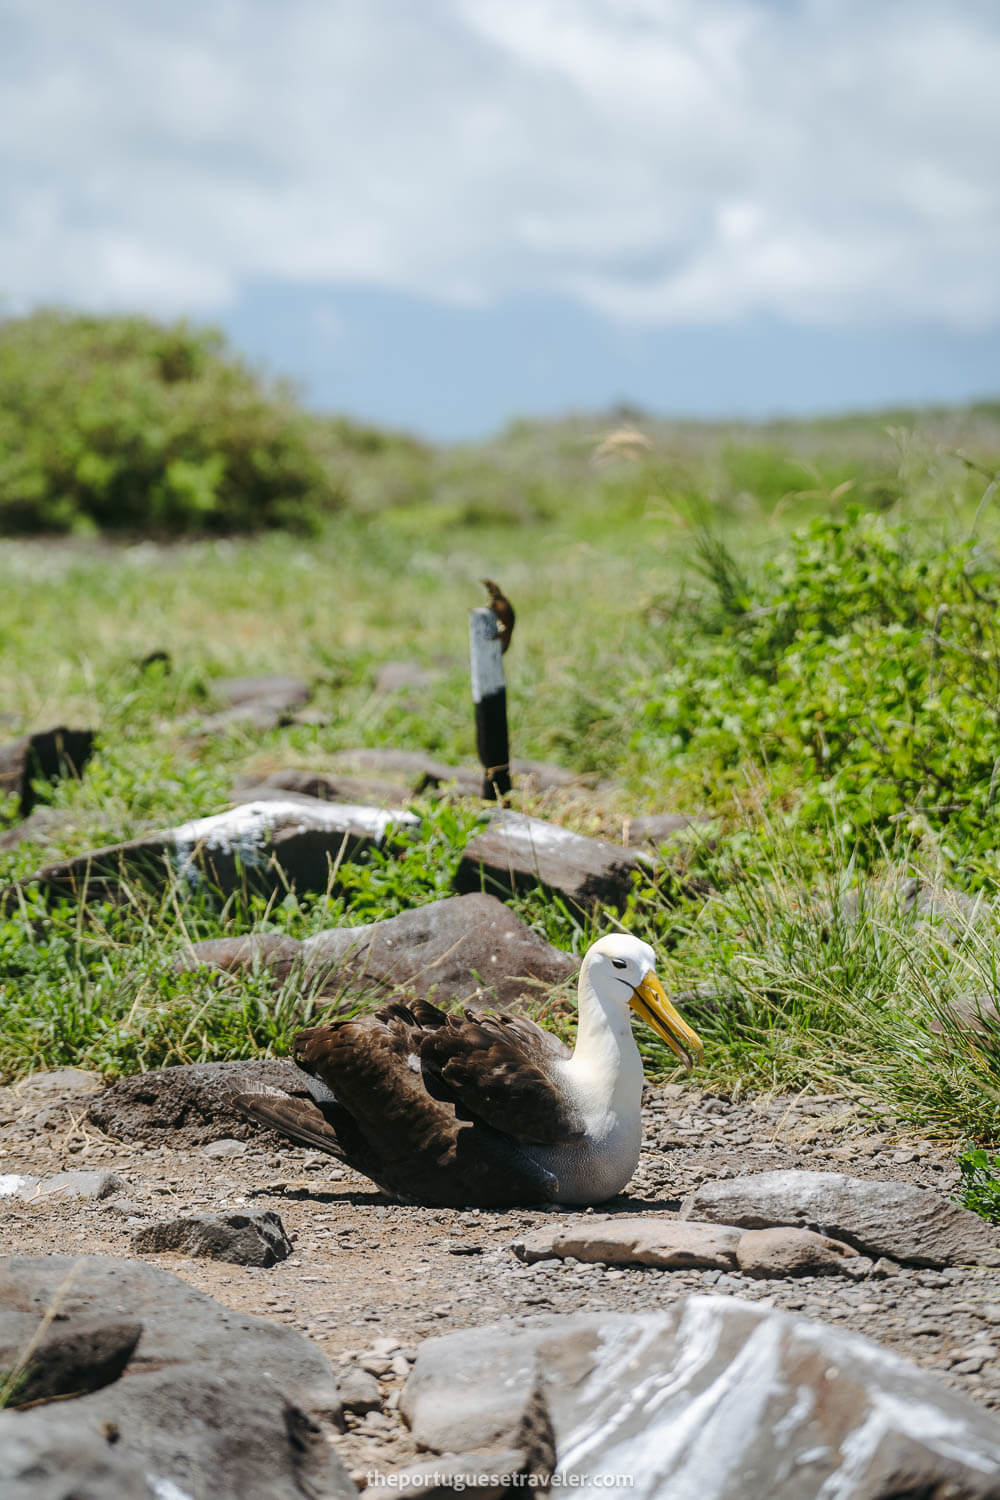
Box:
[0,312,343,534]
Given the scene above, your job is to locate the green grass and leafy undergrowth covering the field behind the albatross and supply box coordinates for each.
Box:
[0,407,1000,1145]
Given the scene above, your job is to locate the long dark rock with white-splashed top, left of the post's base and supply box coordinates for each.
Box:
[20,798,418,900]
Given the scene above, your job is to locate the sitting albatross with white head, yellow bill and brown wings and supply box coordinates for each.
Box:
[235,933,702,1208]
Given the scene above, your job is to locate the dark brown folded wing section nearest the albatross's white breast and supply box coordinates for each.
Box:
[420,1011,585,1146]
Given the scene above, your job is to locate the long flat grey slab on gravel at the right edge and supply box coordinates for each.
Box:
[681,1172,1000,1266]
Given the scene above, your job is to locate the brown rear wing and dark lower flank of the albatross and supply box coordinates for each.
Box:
[294,1001,556,1208]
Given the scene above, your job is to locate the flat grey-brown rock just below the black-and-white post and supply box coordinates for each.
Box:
[453,810,649,912]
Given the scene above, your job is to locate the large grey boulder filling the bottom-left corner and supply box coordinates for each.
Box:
[0,1256,357,1500]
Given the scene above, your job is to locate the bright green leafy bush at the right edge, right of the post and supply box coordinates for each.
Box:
[640,512,1000,854]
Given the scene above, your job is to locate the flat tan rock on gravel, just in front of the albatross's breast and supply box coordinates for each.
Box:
[513,1214,742,1271]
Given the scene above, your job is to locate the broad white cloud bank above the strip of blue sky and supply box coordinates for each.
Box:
[0,0,1000,329]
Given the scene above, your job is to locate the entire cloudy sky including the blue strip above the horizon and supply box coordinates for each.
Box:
[0,0,1000,438]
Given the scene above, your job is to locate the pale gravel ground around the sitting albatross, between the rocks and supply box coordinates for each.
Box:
[0,1085,1000,1479]
